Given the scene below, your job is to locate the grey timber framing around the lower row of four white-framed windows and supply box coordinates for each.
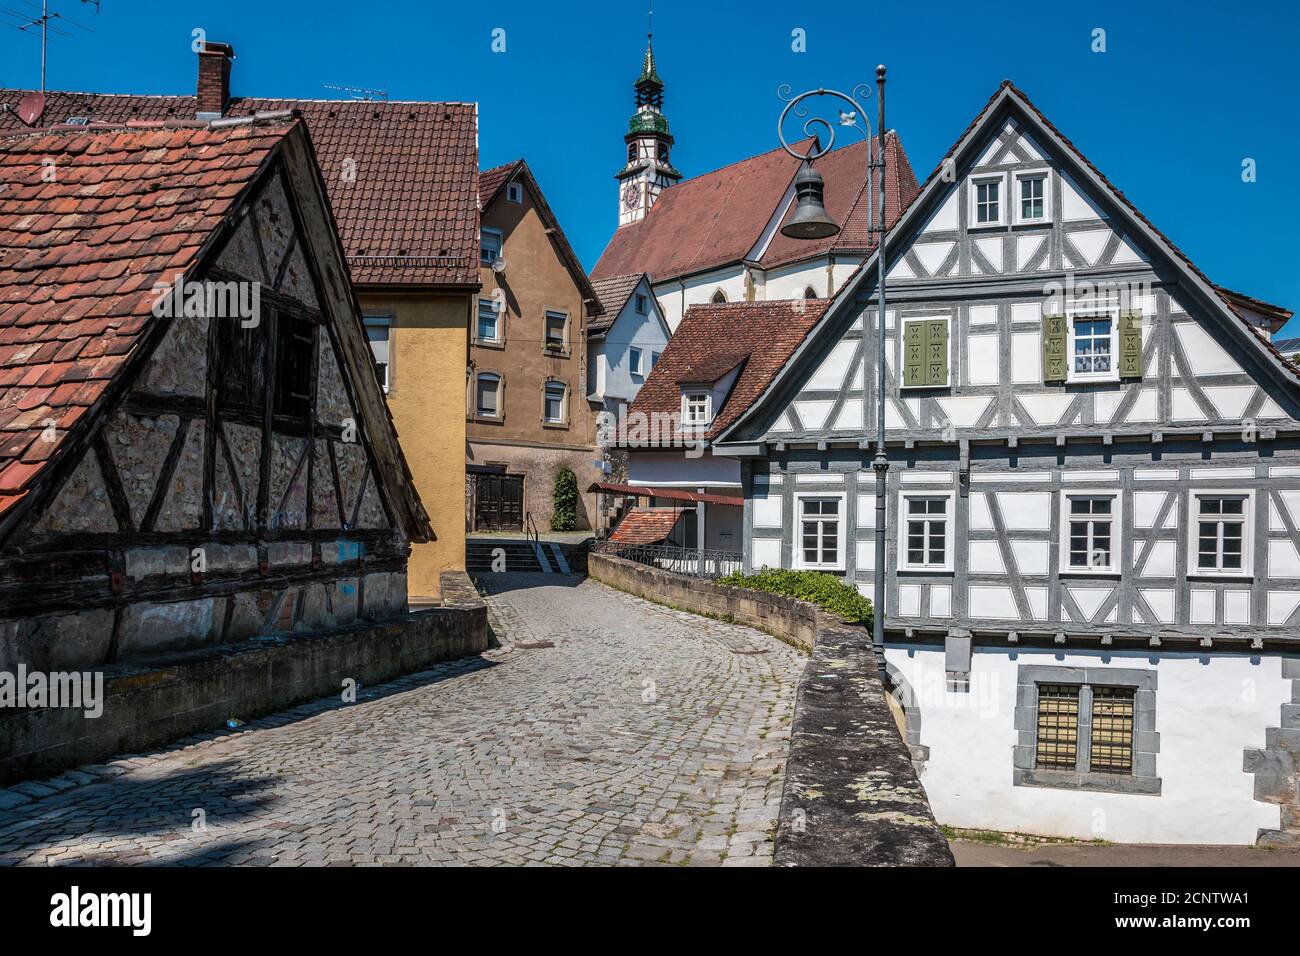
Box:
[759,440,1300,650]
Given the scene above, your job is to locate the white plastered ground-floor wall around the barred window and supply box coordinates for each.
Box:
[885,645,1291,844]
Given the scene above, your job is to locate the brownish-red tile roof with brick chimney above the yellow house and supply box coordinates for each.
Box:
[0,90,478,287]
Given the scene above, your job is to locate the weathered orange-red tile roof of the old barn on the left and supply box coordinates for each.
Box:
[0,118,298,512]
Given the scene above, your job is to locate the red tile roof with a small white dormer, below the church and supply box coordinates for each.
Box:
[628,299,831,440]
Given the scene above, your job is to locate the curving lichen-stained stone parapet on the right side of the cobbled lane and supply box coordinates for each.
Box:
[589,554,954,866]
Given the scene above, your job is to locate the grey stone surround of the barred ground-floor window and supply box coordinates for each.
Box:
[1011,663,1161,796]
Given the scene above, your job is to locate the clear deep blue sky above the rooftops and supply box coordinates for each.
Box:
[0,0,1300,336]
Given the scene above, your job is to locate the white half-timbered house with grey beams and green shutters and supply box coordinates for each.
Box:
[714,83,1300,843]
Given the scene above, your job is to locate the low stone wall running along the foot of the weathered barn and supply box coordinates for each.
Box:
[0,571,488,783]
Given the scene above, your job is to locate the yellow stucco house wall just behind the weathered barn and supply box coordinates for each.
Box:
[359,293,471,601]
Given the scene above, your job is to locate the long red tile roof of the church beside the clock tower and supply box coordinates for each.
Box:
[592,131,918,282]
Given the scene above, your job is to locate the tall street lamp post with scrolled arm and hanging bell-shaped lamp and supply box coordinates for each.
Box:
[776,65,889,670]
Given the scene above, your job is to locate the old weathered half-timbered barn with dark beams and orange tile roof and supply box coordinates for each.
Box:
[0,118,428,667]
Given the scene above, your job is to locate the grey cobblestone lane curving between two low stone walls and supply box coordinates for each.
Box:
[0,575,805,866]
